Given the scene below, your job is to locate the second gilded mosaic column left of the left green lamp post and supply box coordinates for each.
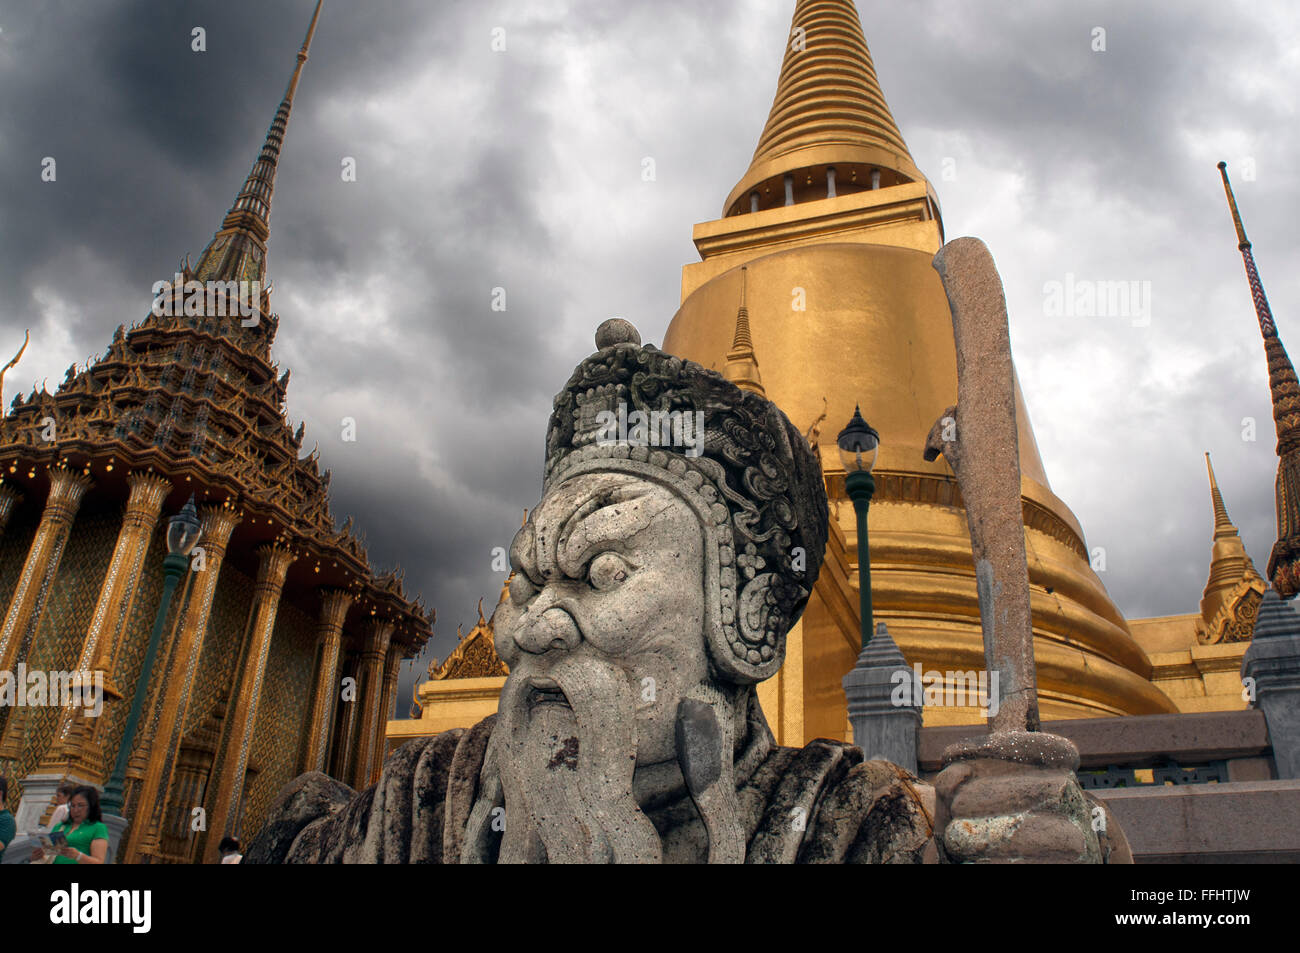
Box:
[0,467,91,738]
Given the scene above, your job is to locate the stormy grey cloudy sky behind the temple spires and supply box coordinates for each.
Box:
[0,0,1300,711]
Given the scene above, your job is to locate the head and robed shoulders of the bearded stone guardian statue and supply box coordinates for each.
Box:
[244,320,1128,863]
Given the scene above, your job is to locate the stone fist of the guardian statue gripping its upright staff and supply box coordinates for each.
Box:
[935,732,1131,863]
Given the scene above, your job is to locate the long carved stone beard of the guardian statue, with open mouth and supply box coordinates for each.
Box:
[471,649,662,863]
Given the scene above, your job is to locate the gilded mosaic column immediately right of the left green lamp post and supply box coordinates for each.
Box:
[121,503,242,863]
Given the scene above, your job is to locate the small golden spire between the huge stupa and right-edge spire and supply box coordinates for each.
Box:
[1196,454,1266,644]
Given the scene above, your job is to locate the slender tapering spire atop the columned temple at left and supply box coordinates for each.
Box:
[194,0,321,282]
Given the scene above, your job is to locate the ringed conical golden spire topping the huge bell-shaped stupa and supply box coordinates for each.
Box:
[723,0,926,216]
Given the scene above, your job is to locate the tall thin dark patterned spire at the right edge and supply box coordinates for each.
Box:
[1218,163,1300,599]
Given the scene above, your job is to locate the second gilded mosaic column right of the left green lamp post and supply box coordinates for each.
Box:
[204,543,298,861]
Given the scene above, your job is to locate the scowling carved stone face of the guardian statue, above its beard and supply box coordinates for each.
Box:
[494,473,709,766]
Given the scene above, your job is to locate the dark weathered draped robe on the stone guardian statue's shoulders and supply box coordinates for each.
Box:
[243,702,933,863]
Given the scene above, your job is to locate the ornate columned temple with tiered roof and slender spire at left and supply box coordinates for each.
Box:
[0,5,433,862]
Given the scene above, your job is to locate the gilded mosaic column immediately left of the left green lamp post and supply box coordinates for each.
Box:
[40,473,172,784]
